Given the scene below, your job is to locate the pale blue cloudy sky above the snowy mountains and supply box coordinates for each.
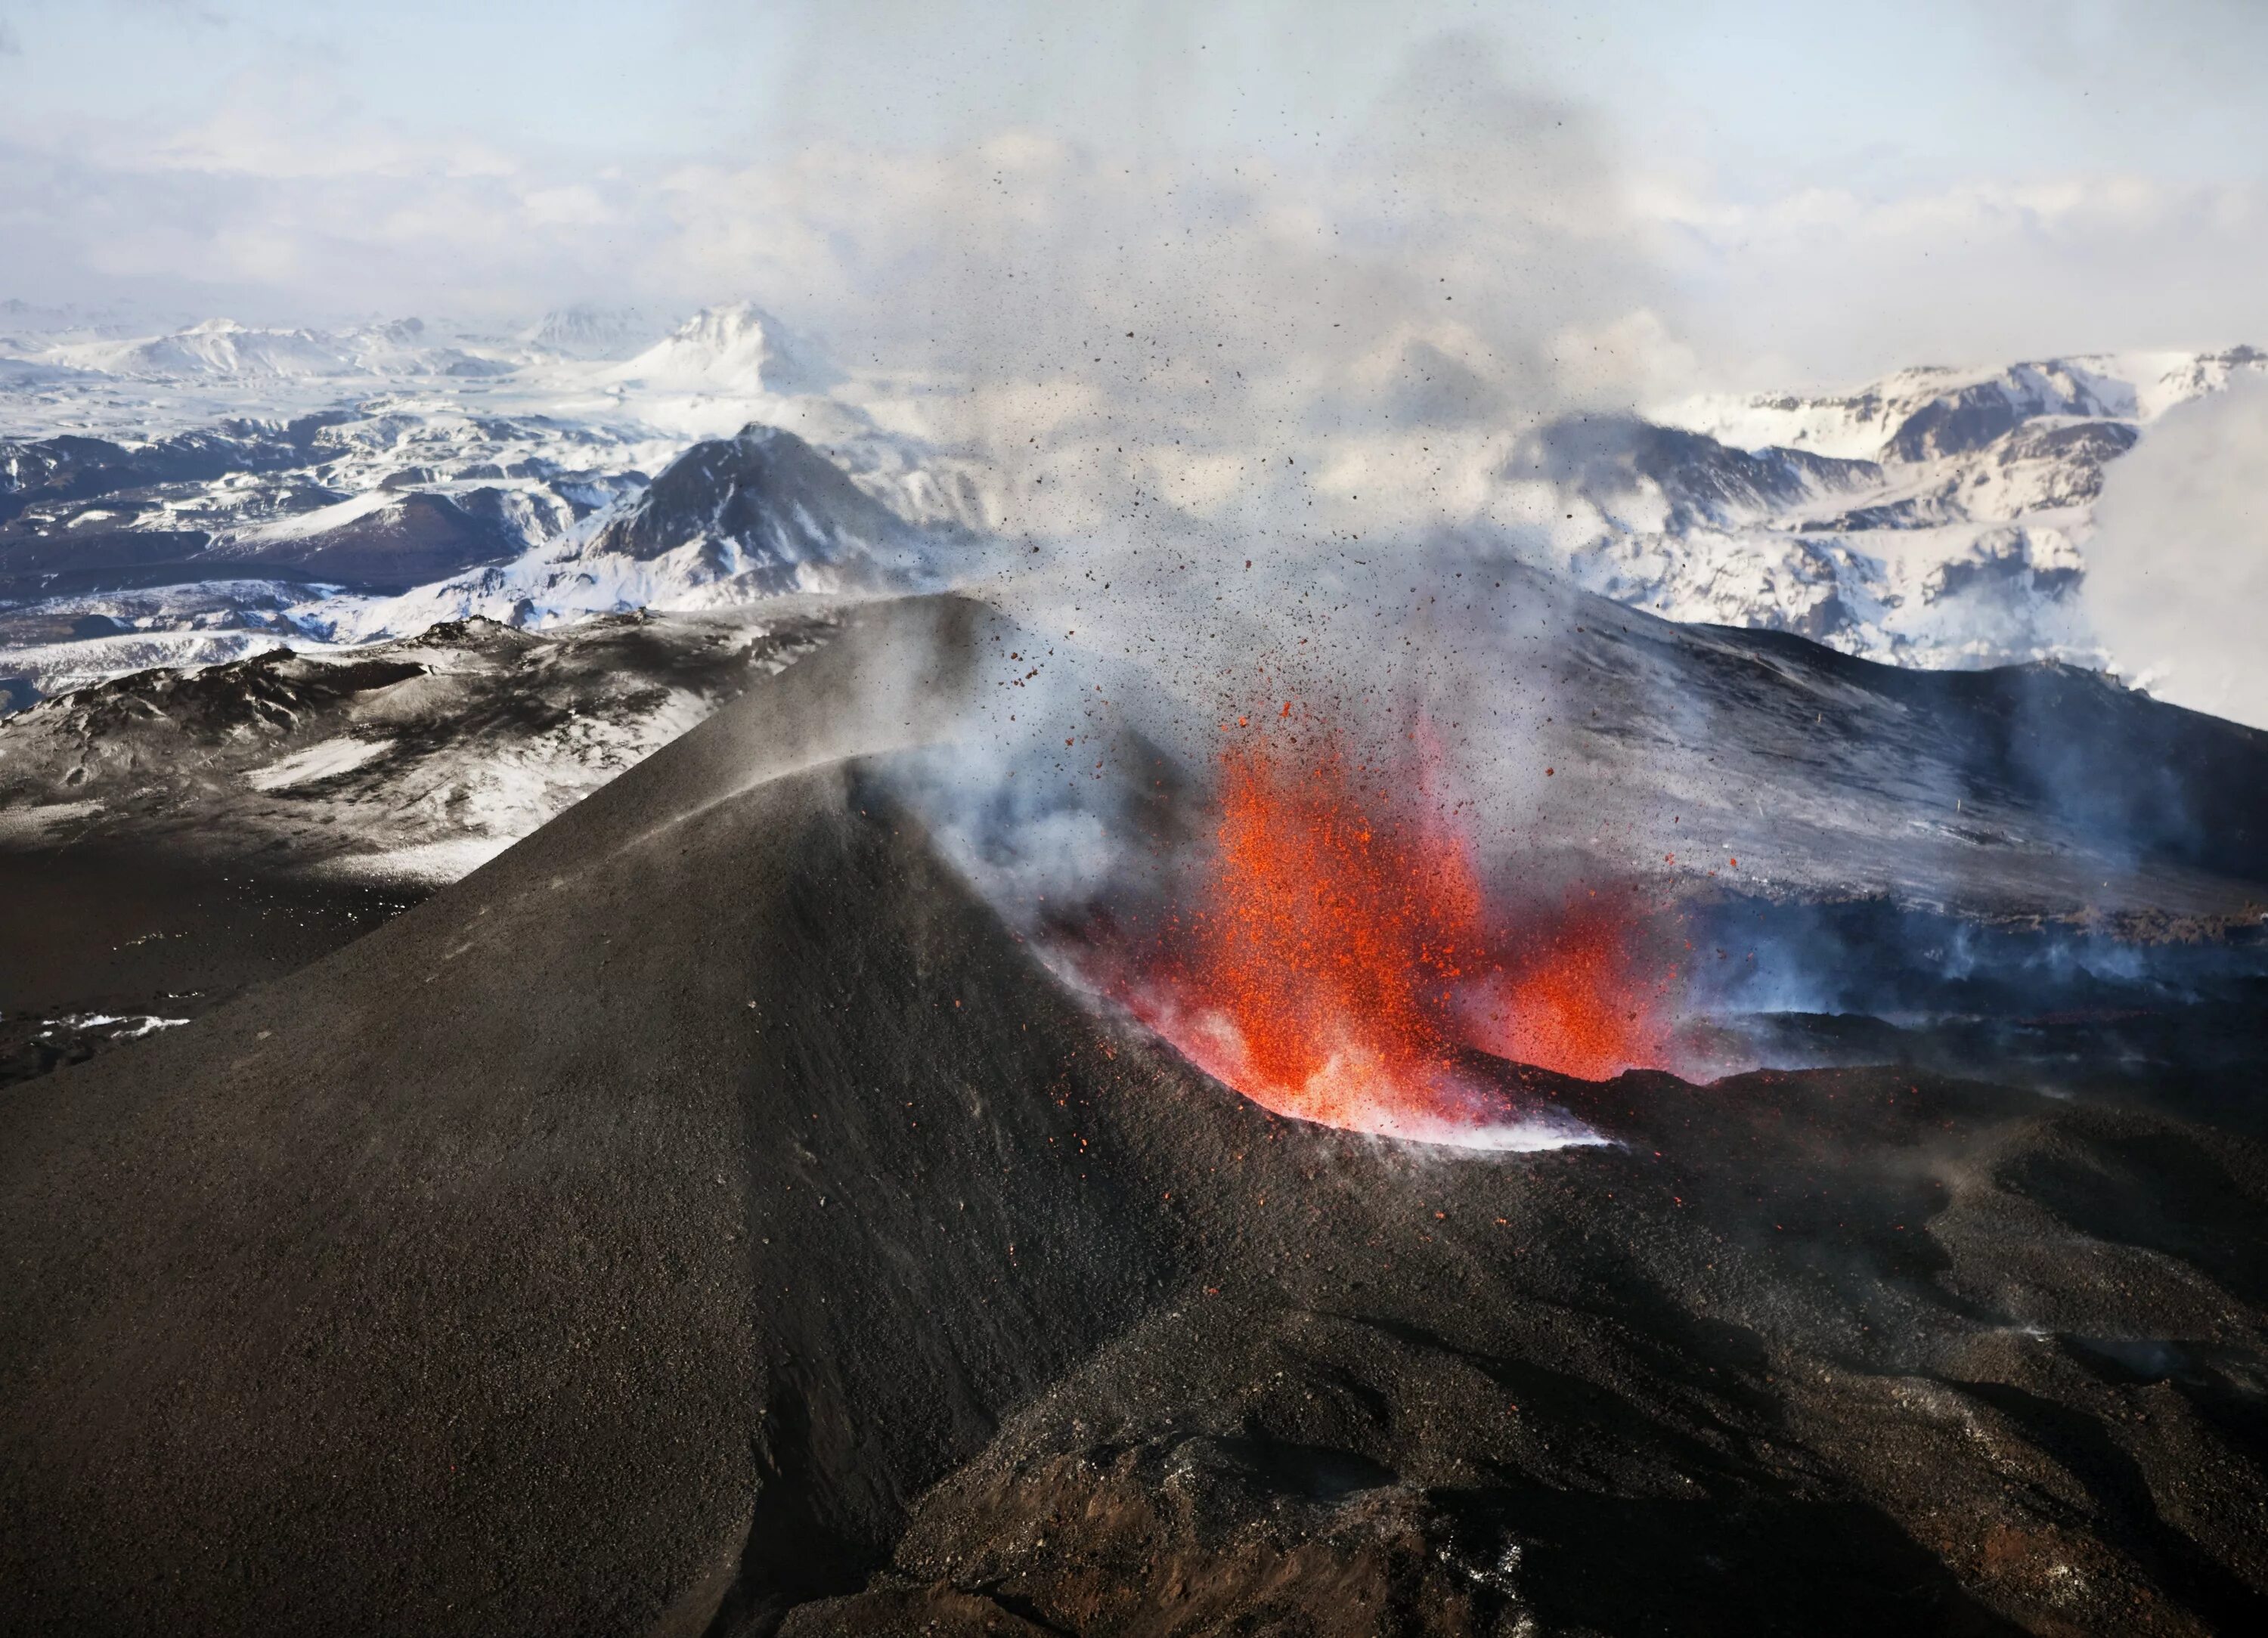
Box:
[0,0,2268,399]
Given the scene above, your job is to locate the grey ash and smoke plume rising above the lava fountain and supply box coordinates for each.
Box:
[830,22,1656,957]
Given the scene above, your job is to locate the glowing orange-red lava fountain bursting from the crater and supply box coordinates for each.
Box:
[1125,705,1658,1148]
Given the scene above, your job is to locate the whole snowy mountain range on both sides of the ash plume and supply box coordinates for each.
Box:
[0,302,2268,705]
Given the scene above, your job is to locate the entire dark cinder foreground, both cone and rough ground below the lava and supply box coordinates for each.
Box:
[0,599,2268,1633]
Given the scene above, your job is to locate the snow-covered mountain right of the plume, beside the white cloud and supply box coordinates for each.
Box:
[1499,347,2268,664]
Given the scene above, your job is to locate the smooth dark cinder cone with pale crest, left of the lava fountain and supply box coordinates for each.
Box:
[0,599,1170,1633]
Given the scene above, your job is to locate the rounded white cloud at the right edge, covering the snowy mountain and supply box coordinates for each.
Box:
[2084,376,2268,728]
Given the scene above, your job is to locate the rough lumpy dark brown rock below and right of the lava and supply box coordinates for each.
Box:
[789,1057,2268,1633]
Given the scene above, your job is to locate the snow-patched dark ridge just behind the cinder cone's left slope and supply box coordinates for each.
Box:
[0,612,830,881]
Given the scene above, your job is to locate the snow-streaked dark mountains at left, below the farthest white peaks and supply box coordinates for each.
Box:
[0,415,973,708]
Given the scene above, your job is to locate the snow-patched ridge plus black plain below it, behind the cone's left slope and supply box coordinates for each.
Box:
[0,610,828,1085]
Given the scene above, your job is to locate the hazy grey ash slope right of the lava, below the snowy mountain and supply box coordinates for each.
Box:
[1538,599,2268,926]
